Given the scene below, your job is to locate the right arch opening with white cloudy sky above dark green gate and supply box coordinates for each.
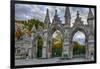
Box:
[72,31,86,58]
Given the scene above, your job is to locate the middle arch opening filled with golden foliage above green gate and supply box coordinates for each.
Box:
[52,30,63,57]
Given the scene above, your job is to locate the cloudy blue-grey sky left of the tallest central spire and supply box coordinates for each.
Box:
[15,4,64,21]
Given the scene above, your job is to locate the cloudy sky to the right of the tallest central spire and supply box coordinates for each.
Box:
[70,7,94,24]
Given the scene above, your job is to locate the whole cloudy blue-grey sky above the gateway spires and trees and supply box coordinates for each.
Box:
[15,4,94,24]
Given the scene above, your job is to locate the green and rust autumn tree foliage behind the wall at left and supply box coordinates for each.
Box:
[15,19,44,39]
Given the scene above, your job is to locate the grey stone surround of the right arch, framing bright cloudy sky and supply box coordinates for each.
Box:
[69,27,89,58]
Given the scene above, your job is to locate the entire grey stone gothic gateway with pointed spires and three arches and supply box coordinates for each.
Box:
[29,7,94,58]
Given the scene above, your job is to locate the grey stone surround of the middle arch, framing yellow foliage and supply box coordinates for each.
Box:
[48,25,64,57]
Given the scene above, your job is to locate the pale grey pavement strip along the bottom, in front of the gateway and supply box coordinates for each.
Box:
[15,58,93,66]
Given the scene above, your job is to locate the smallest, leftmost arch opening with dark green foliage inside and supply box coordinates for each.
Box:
[31,34,44,58]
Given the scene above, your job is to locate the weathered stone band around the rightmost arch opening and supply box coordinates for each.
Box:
[69,27,88,58]
